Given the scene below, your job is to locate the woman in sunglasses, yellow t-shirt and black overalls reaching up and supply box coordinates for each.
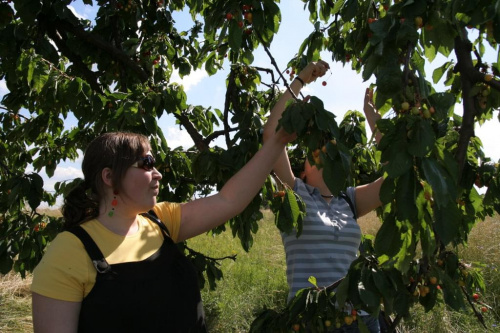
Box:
[31,124,294,333]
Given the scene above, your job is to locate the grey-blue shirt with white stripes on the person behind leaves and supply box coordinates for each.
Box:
[281,178,361,301]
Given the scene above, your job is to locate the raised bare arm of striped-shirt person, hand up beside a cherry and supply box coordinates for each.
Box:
[263,60,330,187]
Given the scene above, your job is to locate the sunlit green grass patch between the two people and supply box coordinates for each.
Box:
[188,212,288,332]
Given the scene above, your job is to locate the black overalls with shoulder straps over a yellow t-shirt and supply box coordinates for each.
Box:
[68,211,207,333]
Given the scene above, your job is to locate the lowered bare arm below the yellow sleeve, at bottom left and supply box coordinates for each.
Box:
[32,293,81,333]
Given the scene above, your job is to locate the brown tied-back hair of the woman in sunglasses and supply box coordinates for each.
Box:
[62,132,151,229]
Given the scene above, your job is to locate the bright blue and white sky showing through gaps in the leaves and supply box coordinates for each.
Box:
[0,0,500,202]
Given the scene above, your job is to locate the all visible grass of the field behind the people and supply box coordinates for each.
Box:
[0,211,500,333]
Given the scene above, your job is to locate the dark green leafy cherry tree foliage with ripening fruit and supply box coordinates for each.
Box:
[0,0,500,327]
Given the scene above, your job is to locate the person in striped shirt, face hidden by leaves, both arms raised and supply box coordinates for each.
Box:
[264,60,383,332]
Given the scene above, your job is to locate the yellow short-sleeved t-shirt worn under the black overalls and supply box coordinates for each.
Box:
[31,202,181,302]
